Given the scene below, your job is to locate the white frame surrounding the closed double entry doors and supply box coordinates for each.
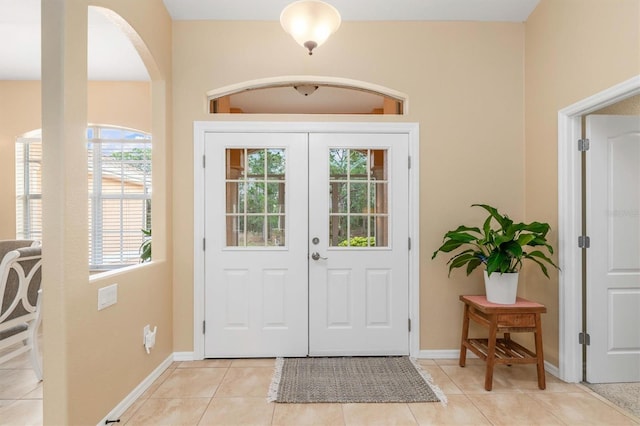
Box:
[193,121,420,360]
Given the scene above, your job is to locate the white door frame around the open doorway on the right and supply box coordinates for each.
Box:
[558,75,640,383]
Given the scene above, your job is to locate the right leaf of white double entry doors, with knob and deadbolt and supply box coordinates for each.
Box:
[309,133,409,355]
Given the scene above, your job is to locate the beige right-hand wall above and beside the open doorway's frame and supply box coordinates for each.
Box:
[524,0,640,365]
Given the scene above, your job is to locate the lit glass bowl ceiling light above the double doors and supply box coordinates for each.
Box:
[280,0,341,55]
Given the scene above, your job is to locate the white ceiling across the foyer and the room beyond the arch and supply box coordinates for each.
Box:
[0,0,539,80]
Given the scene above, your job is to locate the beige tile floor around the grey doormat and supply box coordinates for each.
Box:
[0,352,640,426]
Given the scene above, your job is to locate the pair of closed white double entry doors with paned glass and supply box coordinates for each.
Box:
[204,132,409,358]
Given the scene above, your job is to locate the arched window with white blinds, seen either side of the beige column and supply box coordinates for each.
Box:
[16,126,151,270]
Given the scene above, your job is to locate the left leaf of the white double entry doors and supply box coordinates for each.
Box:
[204,133,308,358]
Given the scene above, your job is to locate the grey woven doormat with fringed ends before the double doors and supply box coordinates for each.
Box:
[268,356,447,404]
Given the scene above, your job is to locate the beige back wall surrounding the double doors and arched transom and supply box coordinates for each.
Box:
[173,21,524,351]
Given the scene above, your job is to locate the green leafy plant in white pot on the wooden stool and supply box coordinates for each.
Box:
[431,204,557,304]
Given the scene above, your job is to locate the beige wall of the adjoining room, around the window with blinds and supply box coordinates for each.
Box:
[0,81,151,240]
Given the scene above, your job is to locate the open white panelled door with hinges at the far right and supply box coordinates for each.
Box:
[586,115,640,383]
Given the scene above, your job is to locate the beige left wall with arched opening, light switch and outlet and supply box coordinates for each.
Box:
[42,0,173,425]
